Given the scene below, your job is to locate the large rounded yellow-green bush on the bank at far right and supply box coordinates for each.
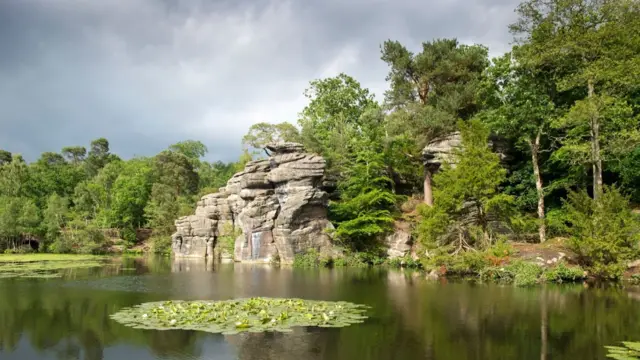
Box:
[565,187,640,278]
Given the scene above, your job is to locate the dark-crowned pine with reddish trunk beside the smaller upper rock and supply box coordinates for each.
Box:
[381,39,488,205]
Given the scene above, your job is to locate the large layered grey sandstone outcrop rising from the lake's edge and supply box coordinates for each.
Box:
[172,143,332,263]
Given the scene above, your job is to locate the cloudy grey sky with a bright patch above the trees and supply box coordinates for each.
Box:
[0,0,519,161]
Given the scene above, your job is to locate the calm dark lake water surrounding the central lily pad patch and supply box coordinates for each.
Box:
[0,258,640,360]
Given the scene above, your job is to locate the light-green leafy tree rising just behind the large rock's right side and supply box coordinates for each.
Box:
[298,73,379,174]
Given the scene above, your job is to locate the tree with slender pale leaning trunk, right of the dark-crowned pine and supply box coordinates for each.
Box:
[482,53,556,243]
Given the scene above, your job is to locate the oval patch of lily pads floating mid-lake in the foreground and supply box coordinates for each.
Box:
[111,297,367,335]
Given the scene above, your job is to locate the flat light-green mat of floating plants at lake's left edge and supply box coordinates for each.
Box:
[0,254,105,278]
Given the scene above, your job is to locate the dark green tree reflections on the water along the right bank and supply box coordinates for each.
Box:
[387,272,640,359]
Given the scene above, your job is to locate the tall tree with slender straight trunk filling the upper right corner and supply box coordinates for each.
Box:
[510,0,640,198]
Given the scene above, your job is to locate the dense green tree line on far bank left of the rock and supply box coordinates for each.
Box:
[0,138,246,252]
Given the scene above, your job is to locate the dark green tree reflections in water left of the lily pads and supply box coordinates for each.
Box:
[0,281,204,360]
